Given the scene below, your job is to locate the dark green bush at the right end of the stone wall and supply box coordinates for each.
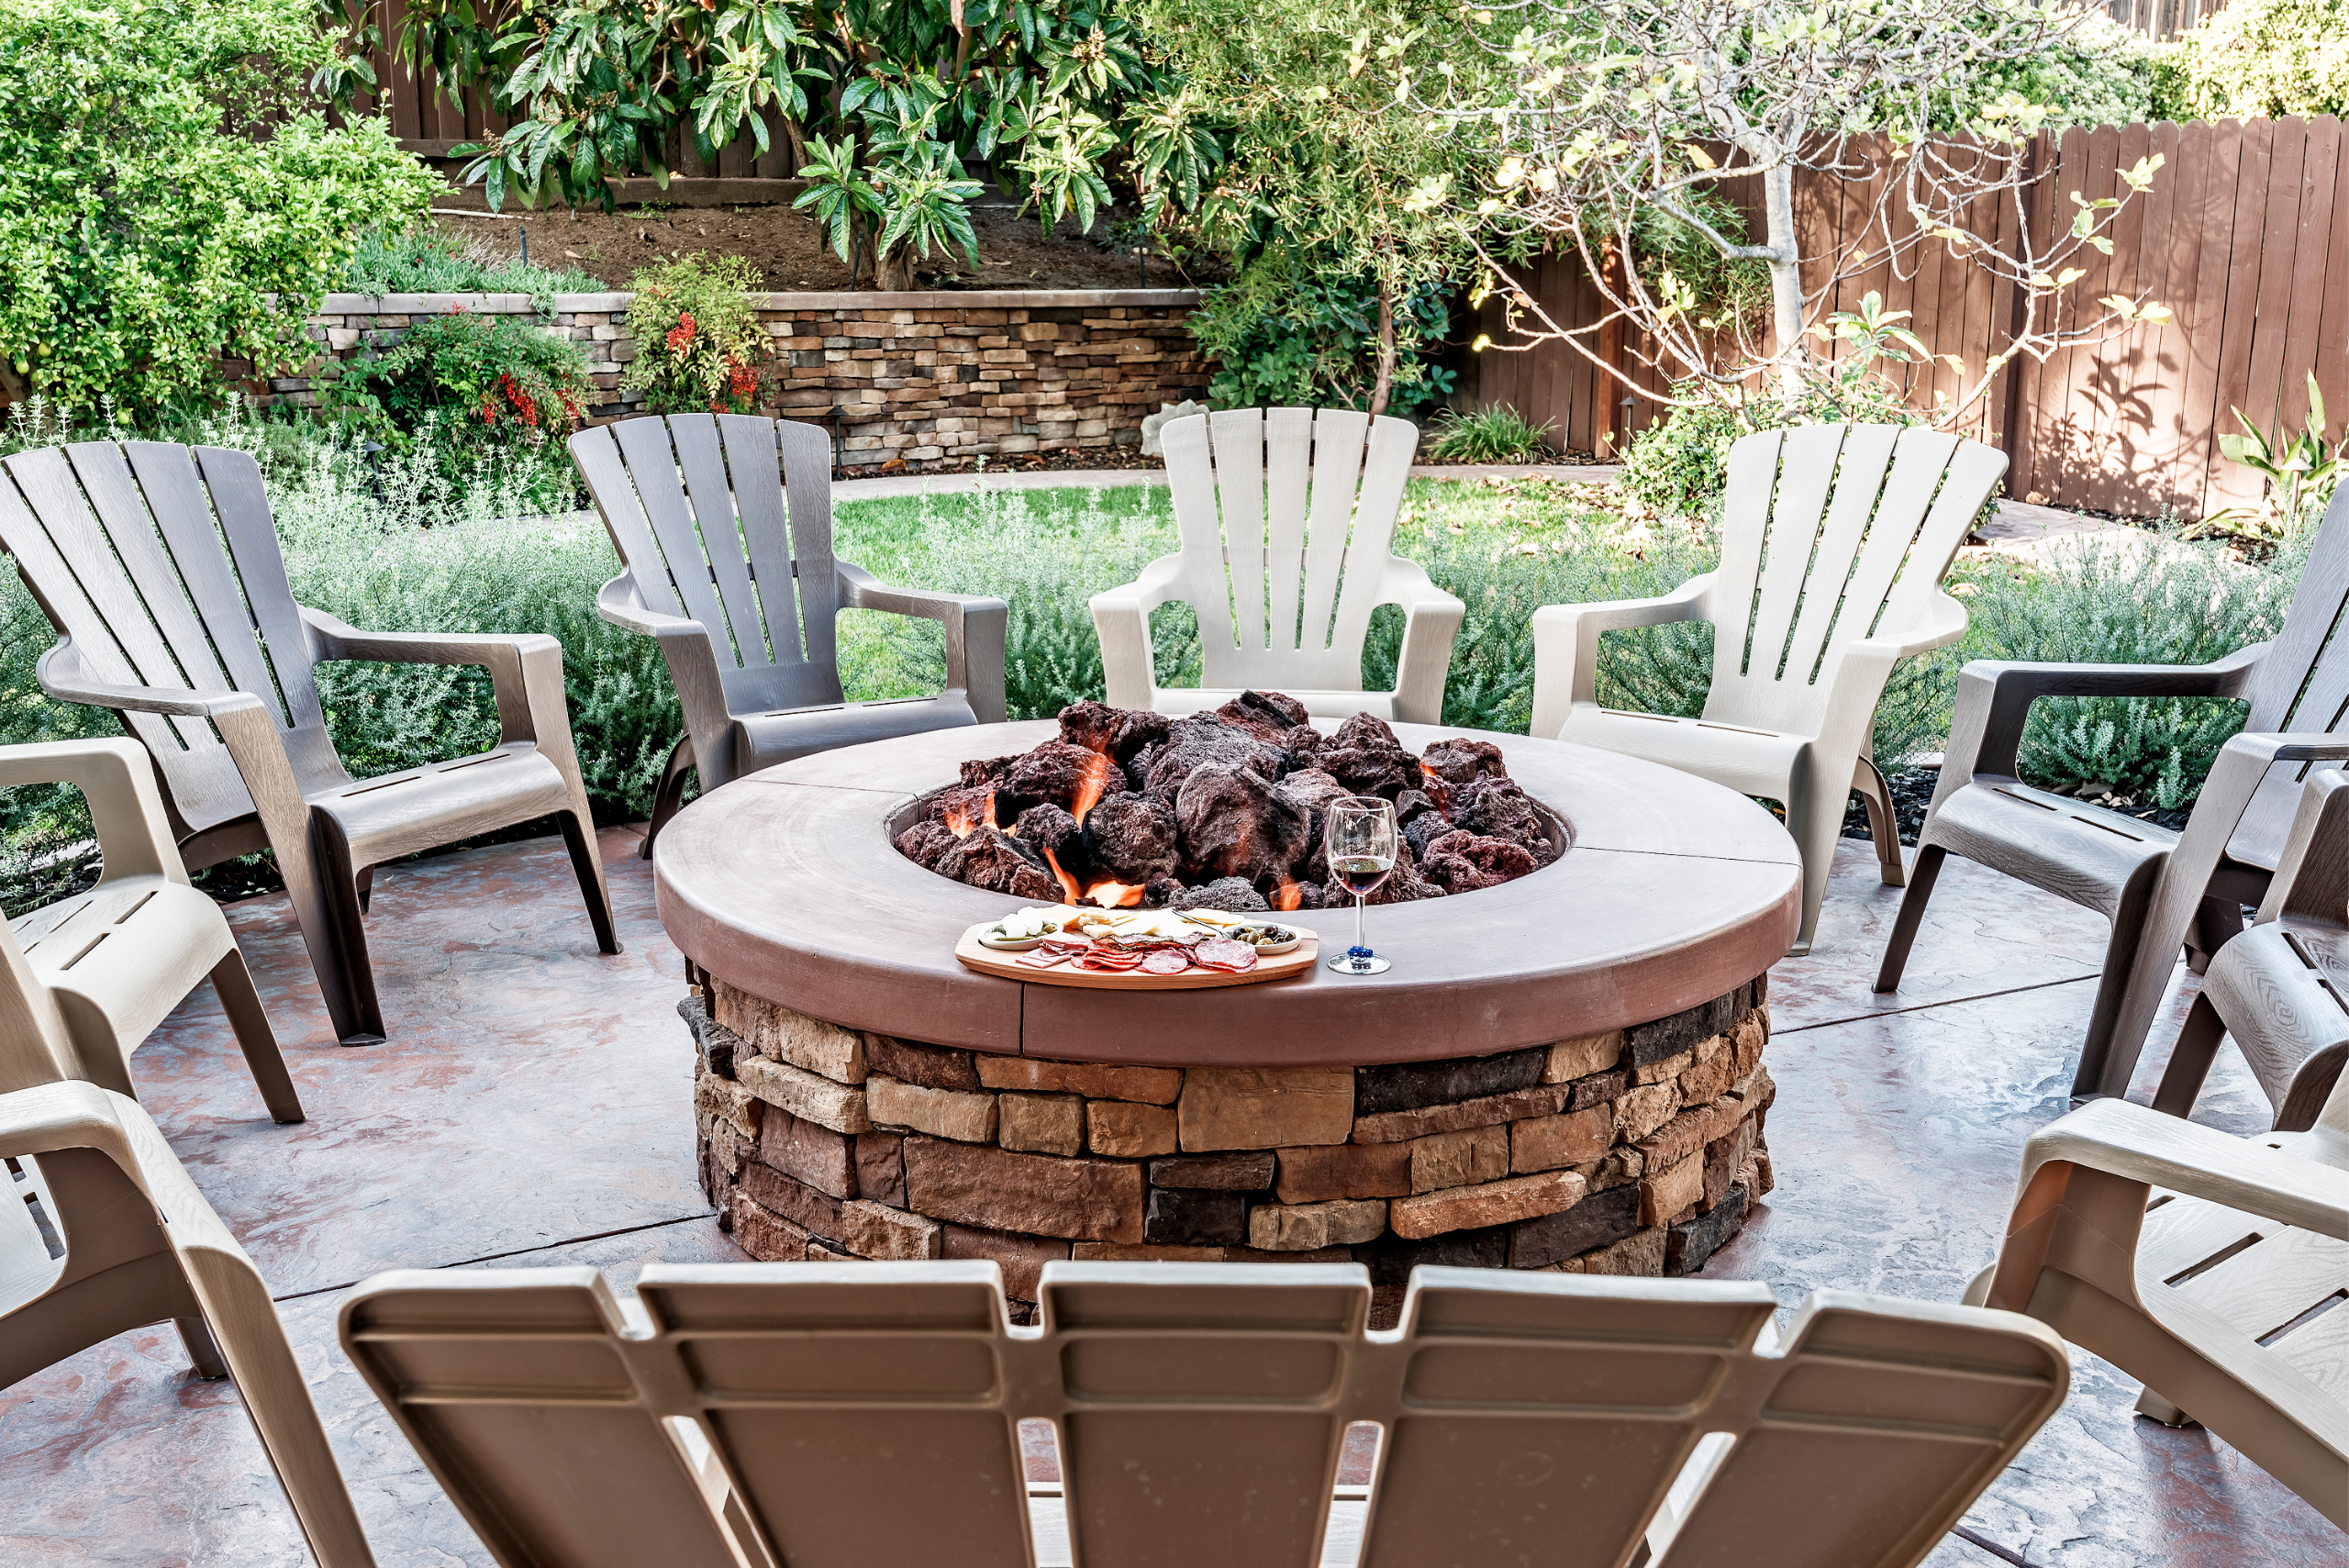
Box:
[1188,247,1454,416]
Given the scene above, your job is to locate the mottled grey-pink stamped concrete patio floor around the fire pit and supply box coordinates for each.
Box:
[0,831,2349,1568]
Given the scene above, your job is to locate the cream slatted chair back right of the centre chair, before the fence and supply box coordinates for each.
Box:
[1706,425,2004,735]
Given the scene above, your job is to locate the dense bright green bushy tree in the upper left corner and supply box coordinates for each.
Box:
[0,0,440,417]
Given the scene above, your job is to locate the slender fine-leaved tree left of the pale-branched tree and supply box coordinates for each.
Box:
[1146,0,1482,413]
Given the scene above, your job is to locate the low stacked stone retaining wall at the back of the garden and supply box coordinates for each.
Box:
[223,289,1208,467]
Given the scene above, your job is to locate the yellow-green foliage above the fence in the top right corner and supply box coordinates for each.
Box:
[2161,0,2349,119]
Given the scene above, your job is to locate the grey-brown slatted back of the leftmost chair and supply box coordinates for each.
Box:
[0,441,350,833]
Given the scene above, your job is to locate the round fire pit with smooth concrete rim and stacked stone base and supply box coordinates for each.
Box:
[653,720,1802,1310]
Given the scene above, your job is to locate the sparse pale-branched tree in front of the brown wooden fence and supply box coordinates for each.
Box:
[1379,0,2165,420]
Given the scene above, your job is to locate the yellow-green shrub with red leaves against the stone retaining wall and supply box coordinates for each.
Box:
[620,256,771,413]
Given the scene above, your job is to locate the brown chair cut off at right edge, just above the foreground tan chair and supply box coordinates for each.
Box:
[2154,773,2349,1131]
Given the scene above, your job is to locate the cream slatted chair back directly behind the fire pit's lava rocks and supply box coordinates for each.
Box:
[1161,408,1419,690]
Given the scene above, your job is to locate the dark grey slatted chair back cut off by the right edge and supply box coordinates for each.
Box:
[2227,486,2349,871]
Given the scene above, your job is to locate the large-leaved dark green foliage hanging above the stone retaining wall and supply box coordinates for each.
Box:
[354,0,1217,289]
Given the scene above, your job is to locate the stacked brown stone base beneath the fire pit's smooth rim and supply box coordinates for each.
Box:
[679,979,1776,1324]
